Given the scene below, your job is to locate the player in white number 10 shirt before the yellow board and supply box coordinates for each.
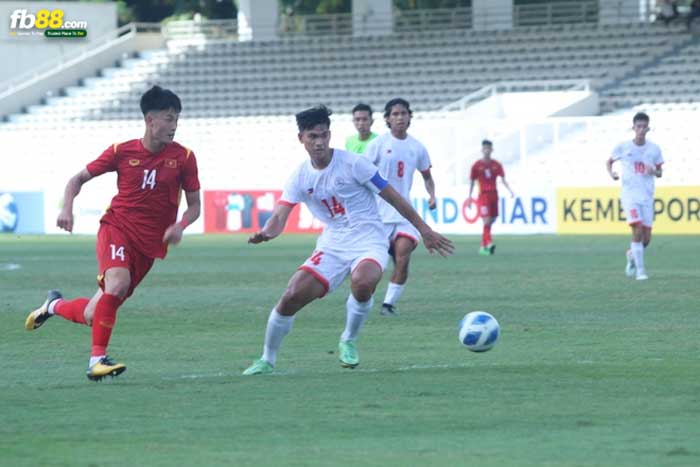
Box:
[606,112,664,280]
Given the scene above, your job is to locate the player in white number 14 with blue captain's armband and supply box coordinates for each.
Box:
[243,106,453,375]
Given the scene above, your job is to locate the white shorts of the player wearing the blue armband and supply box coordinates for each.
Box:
[299,243,389,295]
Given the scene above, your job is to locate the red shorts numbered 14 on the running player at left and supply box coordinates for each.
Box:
[95,224,154,298]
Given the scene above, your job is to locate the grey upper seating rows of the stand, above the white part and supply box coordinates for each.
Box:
[2,19,700,121]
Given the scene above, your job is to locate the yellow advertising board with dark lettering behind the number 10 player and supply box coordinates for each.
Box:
[557,186,700,234]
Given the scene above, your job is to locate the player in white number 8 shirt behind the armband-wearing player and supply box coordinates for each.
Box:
[365,98,436,316]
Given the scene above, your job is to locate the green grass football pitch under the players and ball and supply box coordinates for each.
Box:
[0,236,700,467]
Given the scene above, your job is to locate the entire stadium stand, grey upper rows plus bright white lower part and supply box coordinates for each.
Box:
[0,4,700,196]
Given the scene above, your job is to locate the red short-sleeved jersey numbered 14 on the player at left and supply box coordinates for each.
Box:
[87,139,199,258]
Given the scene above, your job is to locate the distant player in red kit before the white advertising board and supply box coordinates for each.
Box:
[468,139,513,255]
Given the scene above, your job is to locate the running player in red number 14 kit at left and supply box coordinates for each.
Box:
[25,86,200,381]
